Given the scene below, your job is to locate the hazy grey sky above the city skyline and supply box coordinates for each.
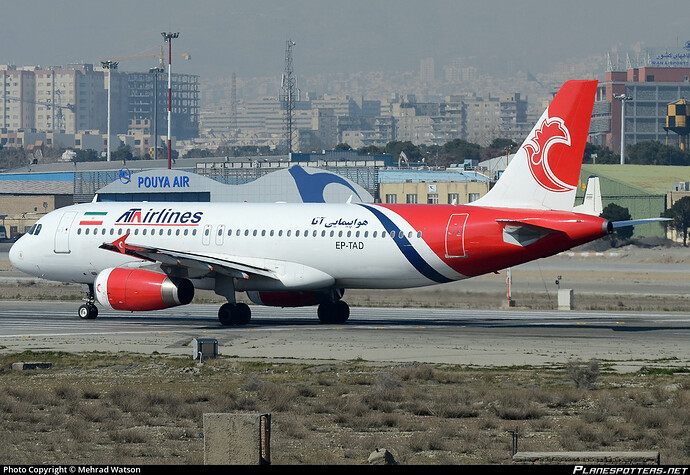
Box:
[5,0,690,81]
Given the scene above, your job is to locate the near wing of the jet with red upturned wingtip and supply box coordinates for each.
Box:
[99,234,279,280]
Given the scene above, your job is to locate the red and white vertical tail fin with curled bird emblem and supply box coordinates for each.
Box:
[471,81,597,211]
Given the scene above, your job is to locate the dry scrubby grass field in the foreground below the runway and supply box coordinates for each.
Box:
[0,353,690,465]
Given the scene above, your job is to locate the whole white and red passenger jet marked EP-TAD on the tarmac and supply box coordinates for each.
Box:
[10,81,624,325]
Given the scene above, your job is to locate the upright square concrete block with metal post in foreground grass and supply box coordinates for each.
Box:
[204,413,270,465]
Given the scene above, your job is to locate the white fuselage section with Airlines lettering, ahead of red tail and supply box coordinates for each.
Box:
[10,202,464,291]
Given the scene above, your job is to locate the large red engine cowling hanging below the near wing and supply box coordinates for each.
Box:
[94,267,194,311]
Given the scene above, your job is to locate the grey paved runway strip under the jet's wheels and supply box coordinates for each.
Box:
[0,301,690,371]
